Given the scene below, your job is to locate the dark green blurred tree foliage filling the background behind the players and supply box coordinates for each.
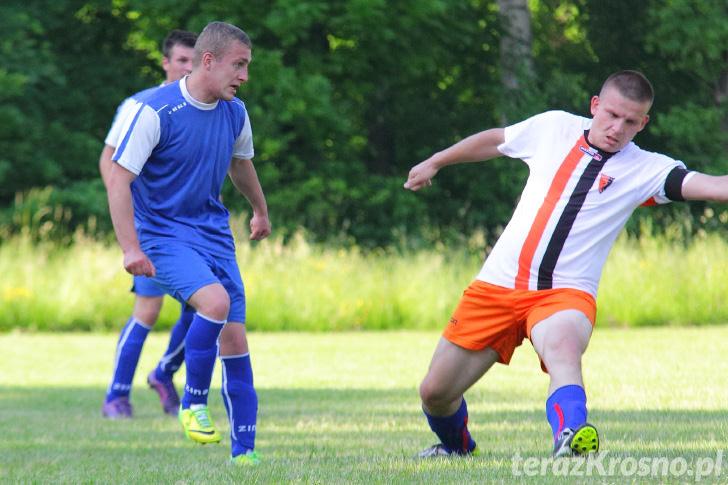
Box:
[0,0,728,247]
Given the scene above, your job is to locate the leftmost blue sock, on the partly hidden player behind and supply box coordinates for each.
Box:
[106,317,151,401]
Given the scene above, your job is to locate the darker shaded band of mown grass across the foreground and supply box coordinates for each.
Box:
[0,387,728,485]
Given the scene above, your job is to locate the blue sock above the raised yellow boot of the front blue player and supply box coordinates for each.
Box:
[181,313,225,409]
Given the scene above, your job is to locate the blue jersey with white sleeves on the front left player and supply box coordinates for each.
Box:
[113,78,253,257]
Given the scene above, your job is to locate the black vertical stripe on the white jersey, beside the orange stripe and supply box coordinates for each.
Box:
[538,150,613,290]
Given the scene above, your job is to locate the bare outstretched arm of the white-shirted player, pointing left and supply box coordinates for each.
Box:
[404,128,505,191]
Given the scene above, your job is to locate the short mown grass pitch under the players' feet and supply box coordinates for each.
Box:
[0,326,728,484]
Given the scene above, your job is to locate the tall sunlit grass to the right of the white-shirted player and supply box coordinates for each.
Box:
[597,230,728,326]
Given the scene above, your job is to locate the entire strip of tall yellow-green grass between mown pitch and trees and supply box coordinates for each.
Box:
[5,226,728,332]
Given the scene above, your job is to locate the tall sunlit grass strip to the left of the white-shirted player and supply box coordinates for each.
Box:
[0,231,482,331]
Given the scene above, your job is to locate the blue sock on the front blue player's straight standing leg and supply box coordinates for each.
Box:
[220,353,258,457]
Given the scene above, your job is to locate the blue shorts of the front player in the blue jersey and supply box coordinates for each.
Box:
[144,243,245,323]
